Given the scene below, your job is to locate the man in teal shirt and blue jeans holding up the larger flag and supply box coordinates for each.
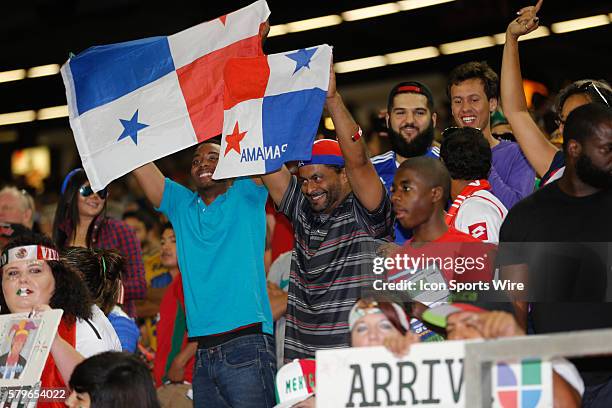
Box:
[133,140,276,408]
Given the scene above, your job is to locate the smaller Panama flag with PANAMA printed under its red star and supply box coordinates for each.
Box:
[213,45,332,179]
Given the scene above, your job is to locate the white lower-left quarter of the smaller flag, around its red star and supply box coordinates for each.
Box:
[213,98,266,180]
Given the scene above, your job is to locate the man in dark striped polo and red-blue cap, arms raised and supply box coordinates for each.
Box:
[262,68,394,362]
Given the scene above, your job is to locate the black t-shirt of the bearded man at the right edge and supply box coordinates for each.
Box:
[500,181,612,383]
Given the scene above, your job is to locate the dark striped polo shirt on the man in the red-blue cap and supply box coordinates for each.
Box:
[280,177,394,362]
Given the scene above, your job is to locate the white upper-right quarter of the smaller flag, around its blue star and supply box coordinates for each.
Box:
[265,44,332,96]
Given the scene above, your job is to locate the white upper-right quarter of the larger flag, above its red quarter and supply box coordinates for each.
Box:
[168,0,270,69]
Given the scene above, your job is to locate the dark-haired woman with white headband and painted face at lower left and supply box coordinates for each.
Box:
[0,234,94,407]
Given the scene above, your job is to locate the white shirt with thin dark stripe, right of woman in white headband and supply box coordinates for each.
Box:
[75,305,122,358]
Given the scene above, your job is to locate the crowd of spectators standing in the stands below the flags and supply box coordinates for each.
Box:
[0,1,612,407]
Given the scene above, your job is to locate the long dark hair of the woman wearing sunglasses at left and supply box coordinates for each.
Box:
[53,169,106,248]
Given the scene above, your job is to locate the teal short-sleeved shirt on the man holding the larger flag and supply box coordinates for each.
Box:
[158,178,273,337]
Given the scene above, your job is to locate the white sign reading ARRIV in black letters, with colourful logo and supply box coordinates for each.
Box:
[316,340,553,408]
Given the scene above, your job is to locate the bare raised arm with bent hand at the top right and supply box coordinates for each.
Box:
[501,0,557,176]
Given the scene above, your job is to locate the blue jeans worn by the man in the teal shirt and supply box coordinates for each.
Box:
[193,334,276,408]
